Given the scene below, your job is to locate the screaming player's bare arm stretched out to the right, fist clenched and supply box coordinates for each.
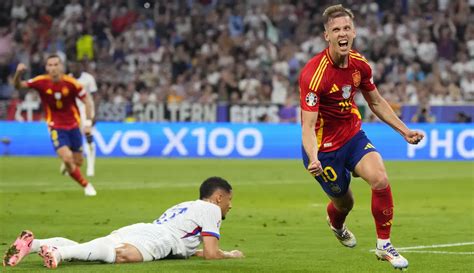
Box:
[362,88,424,144]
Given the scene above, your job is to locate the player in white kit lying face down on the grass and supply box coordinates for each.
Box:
[3,177,244,268]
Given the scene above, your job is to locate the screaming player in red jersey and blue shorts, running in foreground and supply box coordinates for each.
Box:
[299,5,423,269]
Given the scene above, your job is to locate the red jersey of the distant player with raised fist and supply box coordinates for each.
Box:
[27,75,86,130]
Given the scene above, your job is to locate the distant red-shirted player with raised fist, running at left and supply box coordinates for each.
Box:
[13,55,96,196]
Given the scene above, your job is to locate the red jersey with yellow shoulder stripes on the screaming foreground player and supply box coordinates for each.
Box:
[299,48,375,152]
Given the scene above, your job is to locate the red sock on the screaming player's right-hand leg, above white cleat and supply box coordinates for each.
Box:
[372,185,393,239]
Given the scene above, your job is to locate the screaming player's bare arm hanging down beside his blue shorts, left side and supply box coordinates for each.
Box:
[301,110,323,176]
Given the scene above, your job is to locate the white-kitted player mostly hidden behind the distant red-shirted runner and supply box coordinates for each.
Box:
[66,62,97,176]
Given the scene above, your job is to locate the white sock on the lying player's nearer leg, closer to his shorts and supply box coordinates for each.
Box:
[58,237,115,263]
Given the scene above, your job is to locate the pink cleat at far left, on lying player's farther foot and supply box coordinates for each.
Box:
[3,230,35,266]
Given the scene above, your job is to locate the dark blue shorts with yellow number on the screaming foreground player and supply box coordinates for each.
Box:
[302,130,376,197]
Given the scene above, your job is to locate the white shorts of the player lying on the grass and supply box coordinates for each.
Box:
[107,223,176,262]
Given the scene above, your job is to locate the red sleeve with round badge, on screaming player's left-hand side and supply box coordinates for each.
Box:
[299,66,320,112]
